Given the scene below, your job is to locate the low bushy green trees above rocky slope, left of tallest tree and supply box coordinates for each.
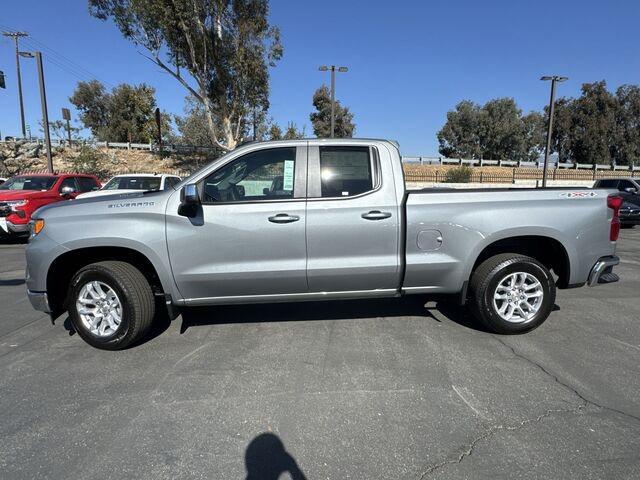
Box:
[69,80,171,143]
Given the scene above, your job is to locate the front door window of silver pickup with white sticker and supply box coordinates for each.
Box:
[203,147,296,203]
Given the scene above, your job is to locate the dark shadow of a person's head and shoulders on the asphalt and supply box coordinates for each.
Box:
[244,433,307,480]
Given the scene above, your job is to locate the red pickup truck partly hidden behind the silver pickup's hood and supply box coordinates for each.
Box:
[0,174,100,238]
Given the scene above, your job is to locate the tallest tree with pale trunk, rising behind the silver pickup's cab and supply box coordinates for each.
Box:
[89,0,282,150]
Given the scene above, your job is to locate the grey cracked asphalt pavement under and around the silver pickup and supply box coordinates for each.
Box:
[0,231,640,480]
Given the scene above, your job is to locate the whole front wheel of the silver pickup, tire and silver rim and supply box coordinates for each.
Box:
[68,261,155,350]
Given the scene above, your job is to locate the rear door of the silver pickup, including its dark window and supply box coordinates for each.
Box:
[307,144,400,294]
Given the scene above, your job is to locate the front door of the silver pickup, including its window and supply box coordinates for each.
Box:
[166,142,308,303]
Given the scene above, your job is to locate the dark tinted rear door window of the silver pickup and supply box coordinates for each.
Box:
[320,147,373,198]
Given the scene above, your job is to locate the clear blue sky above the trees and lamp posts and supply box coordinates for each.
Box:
[0,0,640,156]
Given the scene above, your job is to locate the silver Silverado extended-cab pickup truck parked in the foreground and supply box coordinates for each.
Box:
[27,139,621,349]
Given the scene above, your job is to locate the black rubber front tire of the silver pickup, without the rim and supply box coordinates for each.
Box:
[68,261,155,350]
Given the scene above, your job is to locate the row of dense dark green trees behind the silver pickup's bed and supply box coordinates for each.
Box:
[438,81,640,165]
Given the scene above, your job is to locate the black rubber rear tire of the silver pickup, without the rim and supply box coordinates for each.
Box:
[469,253,556,335]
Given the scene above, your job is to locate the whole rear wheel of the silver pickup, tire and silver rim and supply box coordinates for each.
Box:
[469,253,556,335]
